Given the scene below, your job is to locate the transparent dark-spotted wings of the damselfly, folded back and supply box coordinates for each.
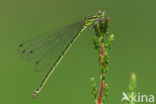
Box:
[18,21,83,71]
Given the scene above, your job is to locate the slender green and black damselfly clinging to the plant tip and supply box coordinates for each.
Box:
[19,11,105,97]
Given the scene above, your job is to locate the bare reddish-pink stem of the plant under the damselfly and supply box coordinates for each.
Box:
[97,42,104,104]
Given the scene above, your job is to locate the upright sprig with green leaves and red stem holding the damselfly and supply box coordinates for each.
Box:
[91,12,114,104]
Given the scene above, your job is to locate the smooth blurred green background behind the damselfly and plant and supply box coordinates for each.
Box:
[0,0,156,104]
